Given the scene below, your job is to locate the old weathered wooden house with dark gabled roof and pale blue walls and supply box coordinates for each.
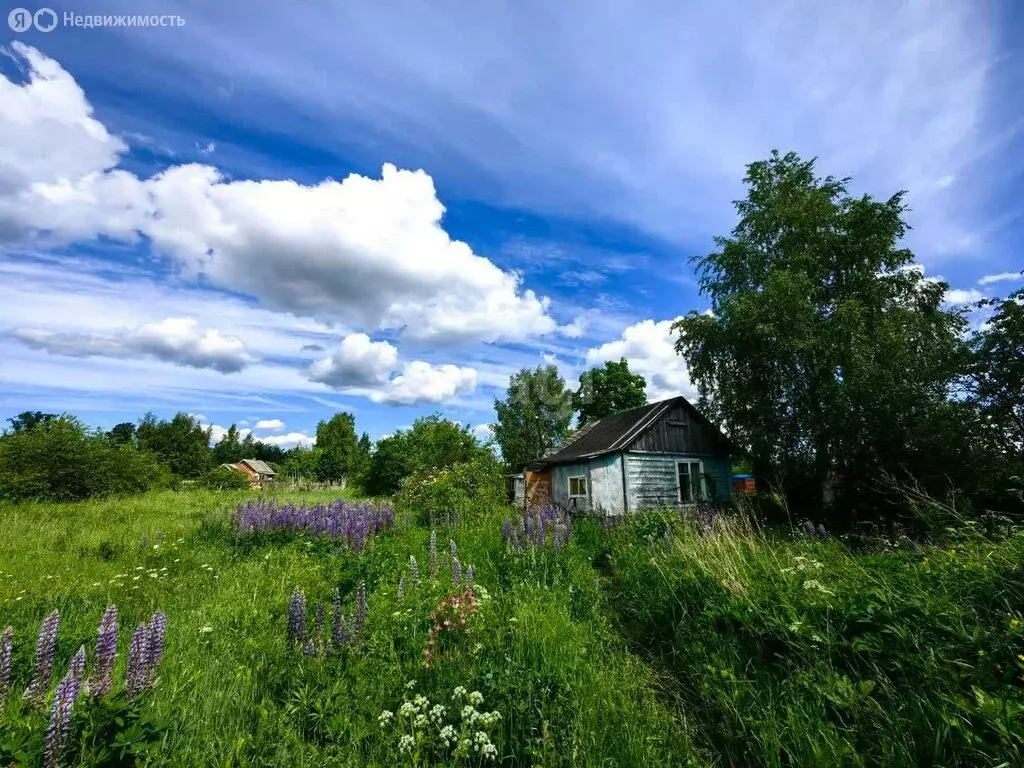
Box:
[523,397,731,515]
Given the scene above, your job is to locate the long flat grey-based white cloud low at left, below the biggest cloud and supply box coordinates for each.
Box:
[11,317,252,374]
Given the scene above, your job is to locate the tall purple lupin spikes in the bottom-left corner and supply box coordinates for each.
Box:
[0,605,167,768]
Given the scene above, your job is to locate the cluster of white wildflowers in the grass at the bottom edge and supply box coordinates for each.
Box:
[377,681,502,765]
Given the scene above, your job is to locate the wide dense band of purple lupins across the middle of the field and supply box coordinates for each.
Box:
[234,499,394,551]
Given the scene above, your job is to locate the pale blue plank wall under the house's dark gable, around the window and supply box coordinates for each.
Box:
[626,453,732,512]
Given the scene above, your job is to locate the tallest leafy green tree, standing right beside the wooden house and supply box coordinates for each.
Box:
[676,152,966,520]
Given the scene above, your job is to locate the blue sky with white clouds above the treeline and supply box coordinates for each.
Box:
[0,0,1024,445]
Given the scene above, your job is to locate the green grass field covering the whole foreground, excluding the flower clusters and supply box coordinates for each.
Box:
[0,492,1024,766]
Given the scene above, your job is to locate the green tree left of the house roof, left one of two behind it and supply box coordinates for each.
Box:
[494,366,572,471]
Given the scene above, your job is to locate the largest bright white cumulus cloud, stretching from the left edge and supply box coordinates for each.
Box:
[0,43,556,342]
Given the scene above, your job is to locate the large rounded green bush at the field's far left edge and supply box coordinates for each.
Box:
[0,417,170,502]
